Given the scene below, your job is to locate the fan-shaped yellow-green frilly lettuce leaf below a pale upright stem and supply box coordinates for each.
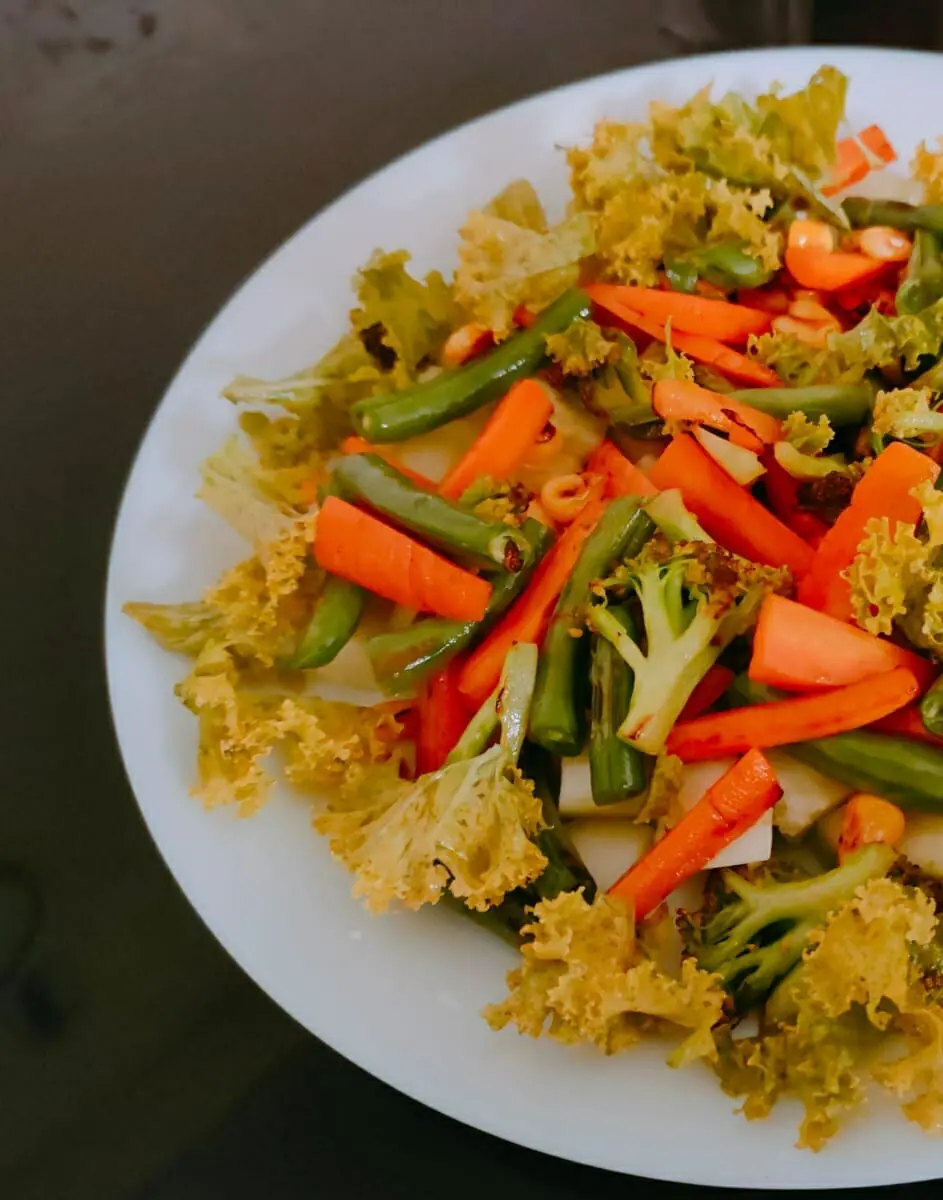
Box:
[314,746,547,912]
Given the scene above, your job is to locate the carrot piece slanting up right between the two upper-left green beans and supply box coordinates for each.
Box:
[439,379,553,500]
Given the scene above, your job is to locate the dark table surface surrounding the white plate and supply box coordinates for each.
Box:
[0,0,943,1200]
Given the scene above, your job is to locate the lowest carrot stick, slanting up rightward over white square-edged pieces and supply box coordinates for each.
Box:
[609,750,782,920]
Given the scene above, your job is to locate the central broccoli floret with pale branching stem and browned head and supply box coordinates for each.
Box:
[587,535,788,755]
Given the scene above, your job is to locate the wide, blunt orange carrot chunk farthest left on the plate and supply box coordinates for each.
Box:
[314,496,491,620]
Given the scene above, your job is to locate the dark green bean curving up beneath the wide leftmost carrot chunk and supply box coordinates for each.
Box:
[367,521,553,695]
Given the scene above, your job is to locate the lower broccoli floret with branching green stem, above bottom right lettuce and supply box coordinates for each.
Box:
[684,844,896,1013]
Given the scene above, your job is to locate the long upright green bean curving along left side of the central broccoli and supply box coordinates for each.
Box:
[530,496,655,756]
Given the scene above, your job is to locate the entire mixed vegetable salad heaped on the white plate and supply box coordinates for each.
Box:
[126,66,943,1150]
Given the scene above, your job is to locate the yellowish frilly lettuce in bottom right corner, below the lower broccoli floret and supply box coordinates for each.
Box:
[716,878,943,1150]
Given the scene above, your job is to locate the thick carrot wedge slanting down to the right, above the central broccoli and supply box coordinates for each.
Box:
[651,433,813,575]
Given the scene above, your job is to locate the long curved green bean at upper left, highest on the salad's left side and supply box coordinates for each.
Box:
[350,288,590,442]
